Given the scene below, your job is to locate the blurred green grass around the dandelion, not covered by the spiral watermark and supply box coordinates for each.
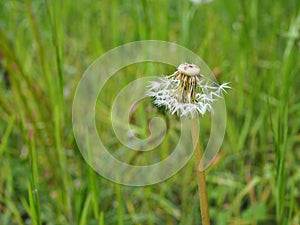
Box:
[0,0,300,225]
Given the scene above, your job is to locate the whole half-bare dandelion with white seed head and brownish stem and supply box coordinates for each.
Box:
[147,63,230,225]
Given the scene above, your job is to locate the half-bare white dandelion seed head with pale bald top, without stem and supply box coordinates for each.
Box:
[146,63,230,118]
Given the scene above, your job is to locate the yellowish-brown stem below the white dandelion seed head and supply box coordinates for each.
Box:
[193,123,210,225]
